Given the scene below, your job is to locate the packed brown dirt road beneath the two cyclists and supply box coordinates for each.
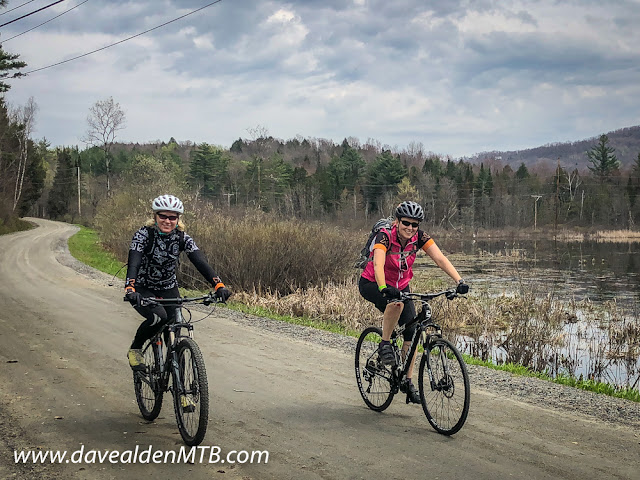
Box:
[0,220,640,480]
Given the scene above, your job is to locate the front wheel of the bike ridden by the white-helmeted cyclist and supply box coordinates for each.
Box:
[173,337,209,446]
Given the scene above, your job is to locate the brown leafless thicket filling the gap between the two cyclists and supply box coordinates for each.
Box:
[184,206,361,295]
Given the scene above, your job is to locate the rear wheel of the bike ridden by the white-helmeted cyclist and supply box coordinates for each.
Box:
[133,338,164,421]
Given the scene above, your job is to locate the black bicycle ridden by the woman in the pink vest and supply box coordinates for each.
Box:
[355,289,470,435]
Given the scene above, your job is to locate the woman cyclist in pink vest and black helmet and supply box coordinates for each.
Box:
[358,201,469,403]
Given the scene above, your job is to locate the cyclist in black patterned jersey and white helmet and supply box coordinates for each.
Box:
[125,195,231,370]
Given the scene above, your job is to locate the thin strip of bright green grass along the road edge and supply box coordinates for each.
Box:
[69,226,640,402]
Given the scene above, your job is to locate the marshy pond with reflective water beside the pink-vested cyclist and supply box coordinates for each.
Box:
[417,239,640,388]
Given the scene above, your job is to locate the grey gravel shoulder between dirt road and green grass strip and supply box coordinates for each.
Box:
[56,242,640,435]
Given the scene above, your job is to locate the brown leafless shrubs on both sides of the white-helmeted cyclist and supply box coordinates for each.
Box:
[96,187,363,296]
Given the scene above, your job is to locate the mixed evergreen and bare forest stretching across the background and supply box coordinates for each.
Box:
[5,109,640,233]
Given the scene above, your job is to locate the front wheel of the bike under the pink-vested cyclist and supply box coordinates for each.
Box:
[418,338,471,435]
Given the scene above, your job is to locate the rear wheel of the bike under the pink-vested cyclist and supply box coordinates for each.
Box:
[355,327,394,412]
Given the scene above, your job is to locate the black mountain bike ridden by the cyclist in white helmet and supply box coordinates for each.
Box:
[133,292,218,446]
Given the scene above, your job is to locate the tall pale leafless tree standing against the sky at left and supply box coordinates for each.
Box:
[82,97,126,195]
